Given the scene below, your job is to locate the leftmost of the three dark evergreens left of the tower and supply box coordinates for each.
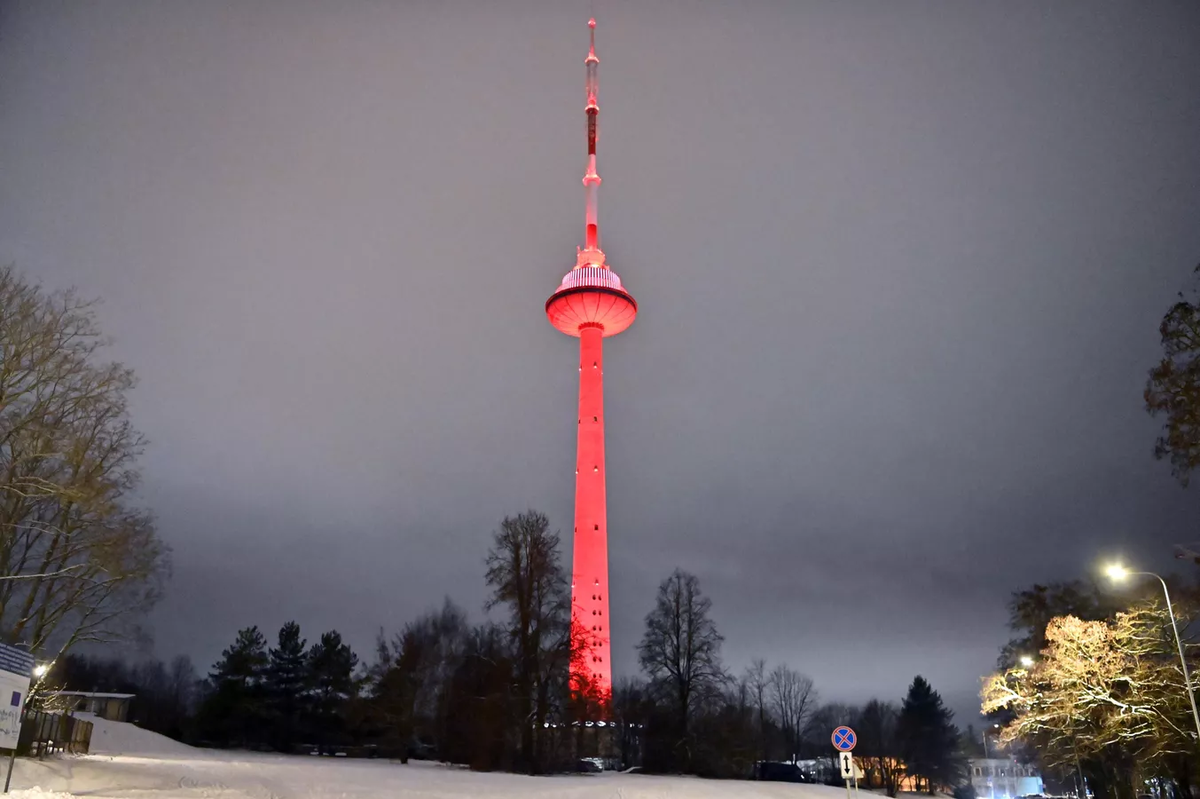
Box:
[202,627,268,746]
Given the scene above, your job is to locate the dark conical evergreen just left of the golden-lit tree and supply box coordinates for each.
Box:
[898,674,962,793]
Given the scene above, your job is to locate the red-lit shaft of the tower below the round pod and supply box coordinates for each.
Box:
[571,325,612,693]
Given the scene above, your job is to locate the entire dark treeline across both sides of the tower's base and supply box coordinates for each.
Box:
[56,511,961,782]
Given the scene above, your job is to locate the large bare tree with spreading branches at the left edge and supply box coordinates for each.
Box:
[0,268,168,657]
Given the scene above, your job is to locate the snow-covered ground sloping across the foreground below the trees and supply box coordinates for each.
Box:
[11,720,844,799]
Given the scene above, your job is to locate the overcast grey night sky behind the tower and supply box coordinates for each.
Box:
[0,0,1200,715]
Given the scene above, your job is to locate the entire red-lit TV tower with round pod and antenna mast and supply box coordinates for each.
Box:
[546,14,637,695]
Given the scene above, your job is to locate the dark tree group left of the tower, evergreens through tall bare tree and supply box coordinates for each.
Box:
[180,511,588,773]
